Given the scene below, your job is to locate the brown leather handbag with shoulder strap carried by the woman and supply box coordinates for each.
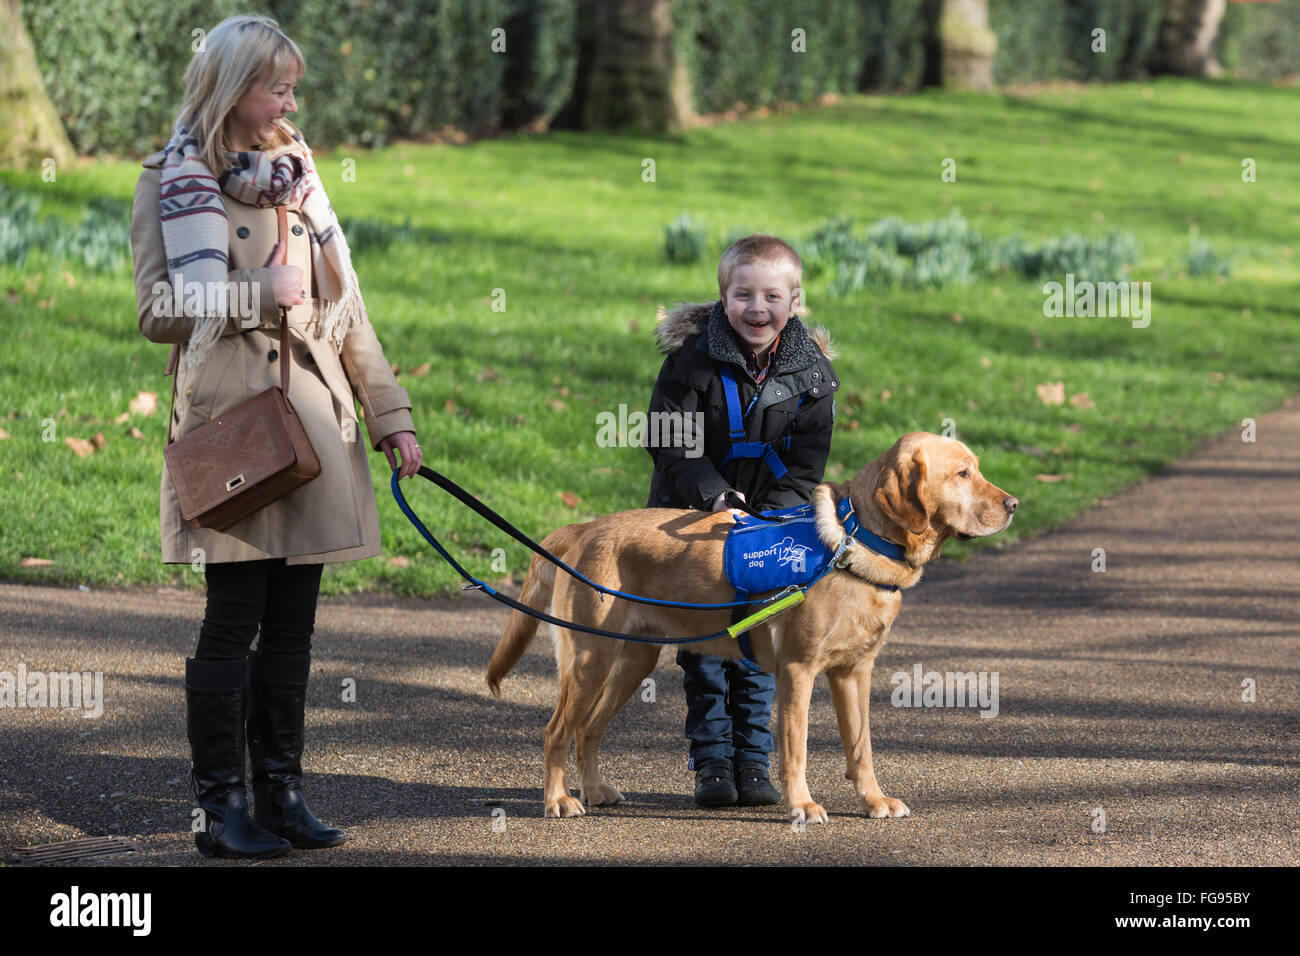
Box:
[163,206,321,531]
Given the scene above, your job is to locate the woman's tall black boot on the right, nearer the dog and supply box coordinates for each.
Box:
[248,652,347,849]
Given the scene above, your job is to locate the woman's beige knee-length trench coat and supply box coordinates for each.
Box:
[131,152,415,564]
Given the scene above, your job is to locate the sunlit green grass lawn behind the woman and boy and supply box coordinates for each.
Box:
[0,81,1300,596]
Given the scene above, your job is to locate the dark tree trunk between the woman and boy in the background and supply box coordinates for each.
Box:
[551,0,692,134]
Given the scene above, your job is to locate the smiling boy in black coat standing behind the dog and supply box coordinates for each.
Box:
[646,235,839,806]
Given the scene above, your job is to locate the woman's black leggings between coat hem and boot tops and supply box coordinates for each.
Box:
[194,558,324,661]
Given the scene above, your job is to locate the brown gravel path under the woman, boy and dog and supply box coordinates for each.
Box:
[0,397,1300,866]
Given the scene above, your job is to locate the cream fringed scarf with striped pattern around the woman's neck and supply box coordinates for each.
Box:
[159,117,367,368]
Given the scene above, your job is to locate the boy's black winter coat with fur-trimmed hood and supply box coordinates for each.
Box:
[646,299,840,511]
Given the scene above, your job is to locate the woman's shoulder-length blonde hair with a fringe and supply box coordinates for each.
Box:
[177,14,307,178]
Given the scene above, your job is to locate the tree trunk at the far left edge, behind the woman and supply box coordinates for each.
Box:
[0,0,77,169]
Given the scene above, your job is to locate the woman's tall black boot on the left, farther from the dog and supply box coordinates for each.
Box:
[185,658,290,860]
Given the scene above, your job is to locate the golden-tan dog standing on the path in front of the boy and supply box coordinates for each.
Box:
[488,432,1017,823]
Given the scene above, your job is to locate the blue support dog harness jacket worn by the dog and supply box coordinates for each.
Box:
[723,498,904,670]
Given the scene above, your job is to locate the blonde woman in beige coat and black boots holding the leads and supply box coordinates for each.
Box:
[131,16,421,858]
